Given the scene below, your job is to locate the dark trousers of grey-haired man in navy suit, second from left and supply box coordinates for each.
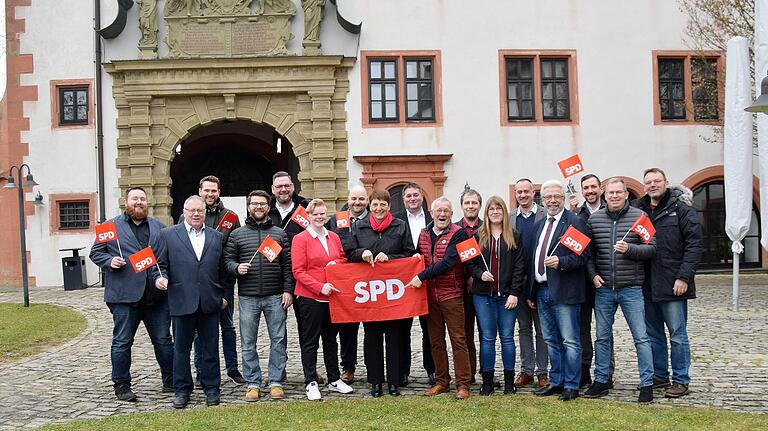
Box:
[173,307,221,396]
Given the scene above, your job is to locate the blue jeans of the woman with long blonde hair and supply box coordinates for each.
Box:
[472,294,520,371]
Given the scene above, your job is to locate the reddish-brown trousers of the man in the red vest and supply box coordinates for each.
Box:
[427,298,472,388]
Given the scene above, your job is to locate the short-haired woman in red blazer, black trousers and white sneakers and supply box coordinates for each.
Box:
[291,199,353,401]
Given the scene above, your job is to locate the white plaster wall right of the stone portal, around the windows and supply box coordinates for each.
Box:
[344,0,722,209]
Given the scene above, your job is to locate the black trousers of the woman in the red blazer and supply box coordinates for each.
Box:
[296,296,340,385]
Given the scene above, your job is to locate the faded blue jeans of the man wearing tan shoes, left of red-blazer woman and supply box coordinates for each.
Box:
[238,295,288,388]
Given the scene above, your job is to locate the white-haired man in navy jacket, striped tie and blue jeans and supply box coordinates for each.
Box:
[528,180,589,401]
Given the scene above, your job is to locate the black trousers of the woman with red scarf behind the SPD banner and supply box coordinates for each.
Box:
[363,319,403,385]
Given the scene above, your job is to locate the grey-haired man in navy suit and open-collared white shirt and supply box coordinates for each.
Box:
[155,195,227,409]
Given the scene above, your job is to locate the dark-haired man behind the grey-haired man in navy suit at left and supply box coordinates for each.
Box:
[179,175,245,387]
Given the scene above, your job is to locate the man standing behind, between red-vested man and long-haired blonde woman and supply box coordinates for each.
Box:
[456,188,483,383]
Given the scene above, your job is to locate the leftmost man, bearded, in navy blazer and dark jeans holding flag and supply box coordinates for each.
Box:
[89,187,173,401]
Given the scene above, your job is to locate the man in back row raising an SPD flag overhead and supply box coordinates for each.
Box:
[570,174,615,388]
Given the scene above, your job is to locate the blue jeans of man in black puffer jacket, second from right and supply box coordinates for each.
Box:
[595,286,653,386]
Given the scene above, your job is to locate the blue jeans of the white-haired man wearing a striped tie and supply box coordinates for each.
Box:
[536,287,581,391]
